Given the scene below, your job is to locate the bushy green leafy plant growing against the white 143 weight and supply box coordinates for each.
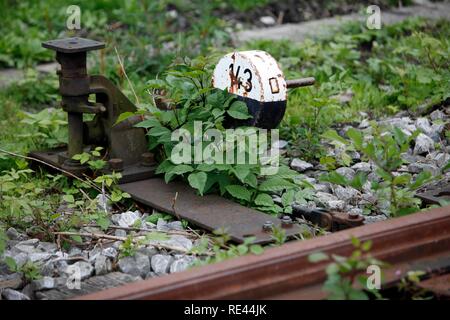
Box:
[120,57,310,214]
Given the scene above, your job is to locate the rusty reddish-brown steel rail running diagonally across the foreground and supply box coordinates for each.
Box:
[78,206,450,299]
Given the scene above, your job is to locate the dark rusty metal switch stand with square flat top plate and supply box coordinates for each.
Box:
[32,37,154,182]
